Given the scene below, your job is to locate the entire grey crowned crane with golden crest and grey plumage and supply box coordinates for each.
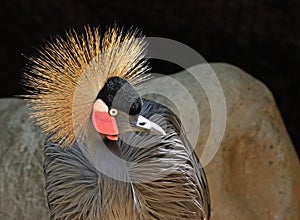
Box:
[24,27,210,220]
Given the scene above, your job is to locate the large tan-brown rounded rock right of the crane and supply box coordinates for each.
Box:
[143,63,300,220]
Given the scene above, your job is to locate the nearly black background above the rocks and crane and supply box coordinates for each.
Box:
[0,0,300,156]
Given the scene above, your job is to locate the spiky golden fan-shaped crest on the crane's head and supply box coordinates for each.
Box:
[24,27,148,147]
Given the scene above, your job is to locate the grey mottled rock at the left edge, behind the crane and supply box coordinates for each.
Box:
[0,99,48,220]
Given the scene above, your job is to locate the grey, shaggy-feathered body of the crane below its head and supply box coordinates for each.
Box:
[44,101,209,220]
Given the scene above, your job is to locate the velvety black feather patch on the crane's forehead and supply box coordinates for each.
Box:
[97,77,142,115]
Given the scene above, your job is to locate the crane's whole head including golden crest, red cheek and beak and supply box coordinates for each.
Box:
[24,27,155,148]
